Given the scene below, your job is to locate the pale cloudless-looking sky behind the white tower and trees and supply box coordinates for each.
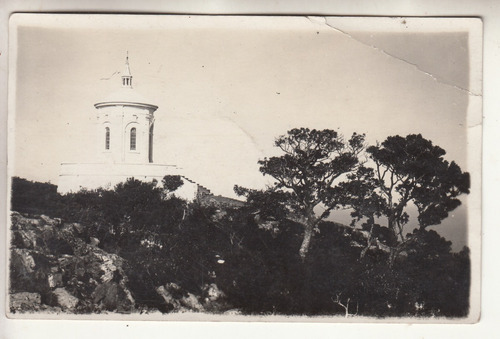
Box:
[9,15,481,248]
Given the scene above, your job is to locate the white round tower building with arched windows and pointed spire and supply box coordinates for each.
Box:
[58,56,205,200]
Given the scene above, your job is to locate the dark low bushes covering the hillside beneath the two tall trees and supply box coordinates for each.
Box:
[11,178,470,317]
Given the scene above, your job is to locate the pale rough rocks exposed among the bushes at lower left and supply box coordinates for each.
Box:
[10,212,227,314]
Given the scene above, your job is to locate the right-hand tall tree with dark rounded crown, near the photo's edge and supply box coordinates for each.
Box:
[367,134,470,241]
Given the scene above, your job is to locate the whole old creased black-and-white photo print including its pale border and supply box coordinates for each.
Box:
[7,14,483,323]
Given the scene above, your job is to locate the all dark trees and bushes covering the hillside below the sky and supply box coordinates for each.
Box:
[10,128,470,317]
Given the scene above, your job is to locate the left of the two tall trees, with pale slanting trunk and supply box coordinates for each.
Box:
[237,128,365,259]
